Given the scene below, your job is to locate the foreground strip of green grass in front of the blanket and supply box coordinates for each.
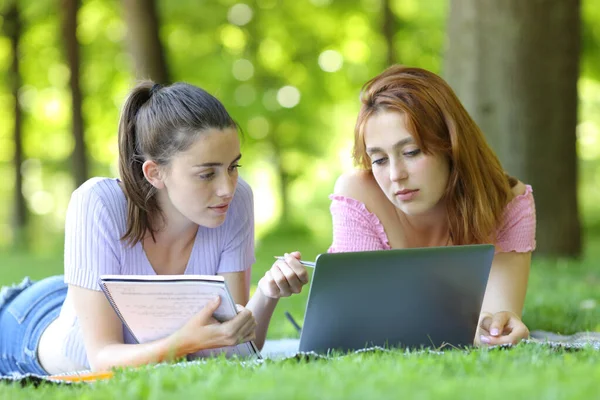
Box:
[0,345,600,400]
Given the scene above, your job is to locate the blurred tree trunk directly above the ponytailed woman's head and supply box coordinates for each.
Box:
[123,0,169,84]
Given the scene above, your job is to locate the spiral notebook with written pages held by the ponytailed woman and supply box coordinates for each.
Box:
[99,275,261,358]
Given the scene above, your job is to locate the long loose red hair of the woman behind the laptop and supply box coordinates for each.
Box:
[352,65,516,245]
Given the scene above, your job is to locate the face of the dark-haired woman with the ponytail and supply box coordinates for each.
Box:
[159,128,241,228]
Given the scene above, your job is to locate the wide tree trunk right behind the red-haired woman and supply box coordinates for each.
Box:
[445,0,581,256]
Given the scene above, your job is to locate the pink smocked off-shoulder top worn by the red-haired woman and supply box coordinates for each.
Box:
[328,185,535,253]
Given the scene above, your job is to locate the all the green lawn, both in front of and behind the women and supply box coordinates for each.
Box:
[0,230,600,399]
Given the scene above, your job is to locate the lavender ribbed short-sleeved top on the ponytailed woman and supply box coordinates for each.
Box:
[56,178,255,368]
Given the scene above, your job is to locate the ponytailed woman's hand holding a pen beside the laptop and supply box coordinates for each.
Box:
[258,251,308,299]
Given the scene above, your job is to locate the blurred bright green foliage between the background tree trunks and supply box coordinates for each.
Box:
[0,0,600,251]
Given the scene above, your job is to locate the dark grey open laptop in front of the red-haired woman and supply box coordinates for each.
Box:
[299,245,494,354]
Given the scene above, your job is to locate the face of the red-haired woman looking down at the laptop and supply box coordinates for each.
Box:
[364,111,450,215]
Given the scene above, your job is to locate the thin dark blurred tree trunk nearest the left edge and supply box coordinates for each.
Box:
[4,0,28,245]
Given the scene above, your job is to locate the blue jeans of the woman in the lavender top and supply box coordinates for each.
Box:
[0,275,67,375]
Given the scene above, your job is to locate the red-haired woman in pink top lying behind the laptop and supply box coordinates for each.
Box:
[329,66,535,345]
